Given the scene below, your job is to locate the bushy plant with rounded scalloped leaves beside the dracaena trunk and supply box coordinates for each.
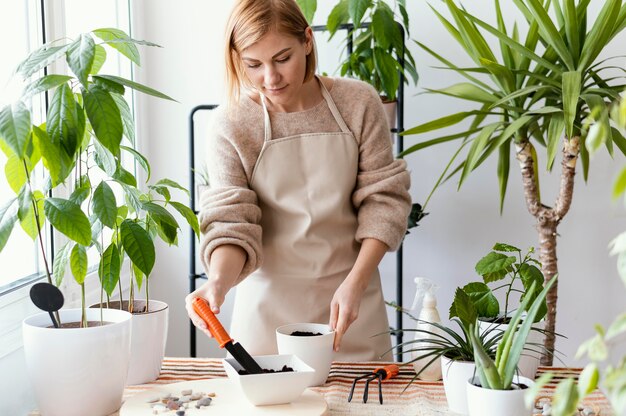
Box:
[456,243,547,322]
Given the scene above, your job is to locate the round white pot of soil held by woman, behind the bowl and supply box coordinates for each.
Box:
[276,323,335,386]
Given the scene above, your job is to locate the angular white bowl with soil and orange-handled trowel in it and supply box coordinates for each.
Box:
[223,355,315,406]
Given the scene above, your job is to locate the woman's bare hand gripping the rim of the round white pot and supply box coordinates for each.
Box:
[329,273,369,351]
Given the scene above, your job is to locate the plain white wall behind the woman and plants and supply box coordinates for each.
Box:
[134,0,626,365]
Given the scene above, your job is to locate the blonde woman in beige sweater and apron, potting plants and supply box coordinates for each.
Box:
[186,0,411,360]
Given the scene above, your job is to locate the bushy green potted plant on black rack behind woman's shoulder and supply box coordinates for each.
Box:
[324,0,418,127]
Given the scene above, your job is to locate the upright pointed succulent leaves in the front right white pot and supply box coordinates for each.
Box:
[469,277,556,390]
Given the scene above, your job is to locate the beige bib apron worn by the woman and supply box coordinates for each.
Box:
[231,77,391,361]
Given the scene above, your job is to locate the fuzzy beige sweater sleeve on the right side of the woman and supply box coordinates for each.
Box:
[352,81,411,251]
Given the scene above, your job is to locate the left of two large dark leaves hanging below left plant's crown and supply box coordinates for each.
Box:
[46,84,82,158]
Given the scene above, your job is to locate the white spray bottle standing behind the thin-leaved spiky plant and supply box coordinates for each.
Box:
[411,277,441,381]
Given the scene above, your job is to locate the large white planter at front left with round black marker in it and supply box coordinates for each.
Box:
[22,309,131,416]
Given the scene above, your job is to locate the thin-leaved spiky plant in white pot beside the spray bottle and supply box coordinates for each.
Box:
[389,288,502,414]
